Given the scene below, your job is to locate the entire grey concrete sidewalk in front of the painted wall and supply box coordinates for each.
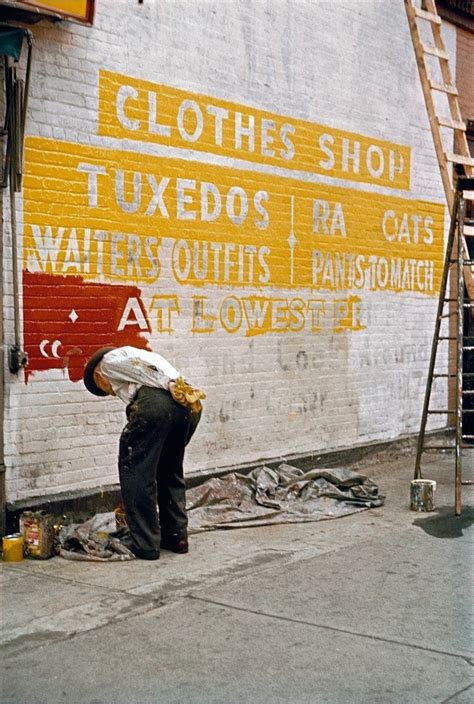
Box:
[2,451,474,704]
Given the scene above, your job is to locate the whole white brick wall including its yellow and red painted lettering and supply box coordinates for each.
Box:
[0,0,453,500]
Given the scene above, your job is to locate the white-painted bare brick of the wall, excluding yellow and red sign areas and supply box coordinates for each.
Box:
[0,0,454,500]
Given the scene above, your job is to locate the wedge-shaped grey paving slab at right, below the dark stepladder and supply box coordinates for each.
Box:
[193,517,474,657]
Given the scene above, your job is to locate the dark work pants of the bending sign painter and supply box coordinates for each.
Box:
[119,386,200,557]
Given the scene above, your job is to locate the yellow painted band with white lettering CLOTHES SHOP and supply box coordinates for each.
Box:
[99,71,410,189]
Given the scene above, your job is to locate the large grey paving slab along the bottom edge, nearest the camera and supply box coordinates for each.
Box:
[3,600,472,704]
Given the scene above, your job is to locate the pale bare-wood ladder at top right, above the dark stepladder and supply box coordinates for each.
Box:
[405,0,474,301]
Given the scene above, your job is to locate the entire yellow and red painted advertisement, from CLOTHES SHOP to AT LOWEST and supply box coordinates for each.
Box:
[23,71,444,381]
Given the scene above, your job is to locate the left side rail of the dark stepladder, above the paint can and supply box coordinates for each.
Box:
[415,191,462,479]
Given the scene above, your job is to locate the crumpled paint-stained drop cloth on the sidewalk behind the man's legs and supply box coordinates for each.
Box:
[59,463,385,561]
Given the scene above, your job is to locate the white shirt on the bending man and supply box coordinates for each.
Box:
[100,347,182,403]
